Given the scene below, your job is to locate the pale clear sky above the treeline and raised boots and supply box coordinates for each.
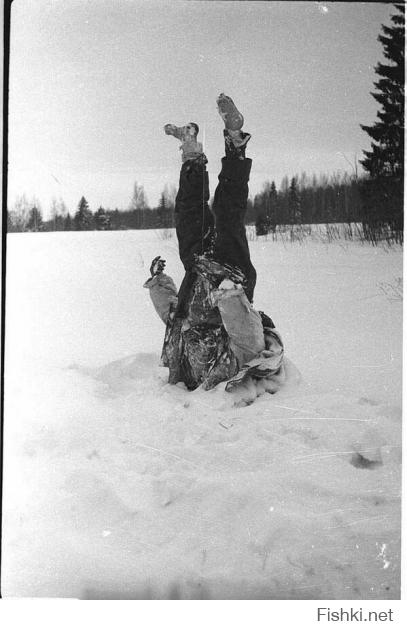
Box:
[9,0,395,215]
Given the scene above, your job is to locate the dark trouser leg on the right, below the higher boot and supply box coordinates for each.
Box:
[213,157,257,302]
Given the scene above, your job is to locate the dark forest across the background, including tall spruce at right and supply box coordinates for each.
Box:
[7,3,405,244]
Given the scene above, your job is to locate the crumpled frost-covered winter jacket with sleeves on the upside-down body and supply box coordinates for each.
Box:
[144,273,284,398]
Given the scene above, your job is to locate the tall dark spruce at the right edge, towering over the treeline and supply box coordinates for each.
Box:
[360,4,405,240]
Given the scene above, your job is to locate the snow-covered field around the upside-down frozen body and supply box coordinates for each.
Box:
[2,231,402,599]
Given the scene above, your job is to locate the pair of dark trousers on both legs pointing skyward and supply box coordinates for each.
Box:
[175,157,256,317]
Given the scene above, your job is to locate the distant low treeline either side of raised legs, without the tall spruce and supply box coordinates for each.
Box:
[7,173,362,235]
